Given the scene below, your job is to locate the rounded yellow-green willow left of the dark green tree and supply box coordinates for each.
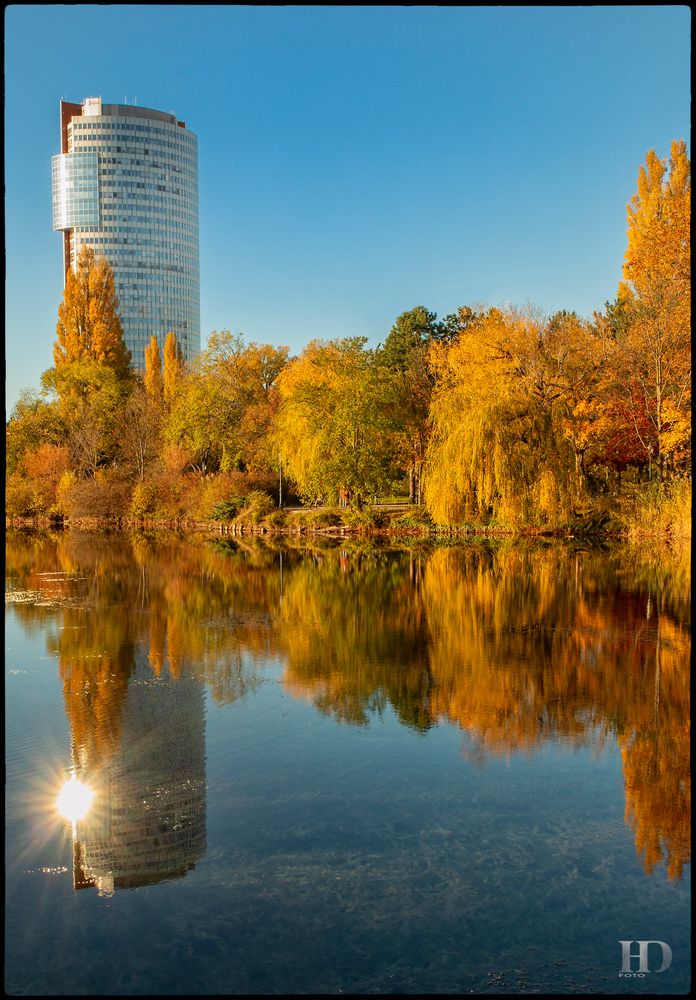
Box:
[274,337,391,507]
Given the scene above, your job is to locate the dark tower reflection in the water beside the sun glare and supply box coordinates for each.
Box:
[63,658,206,895]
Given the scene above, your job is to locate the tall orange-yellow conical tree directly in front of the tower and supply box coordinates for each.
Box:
[53,246,131,378]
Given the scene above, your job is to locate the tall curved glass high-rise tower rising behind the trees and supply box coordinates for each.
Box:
[53,97,201,368]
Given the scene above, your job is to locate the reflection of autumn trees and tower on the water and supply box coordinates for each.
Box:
[7,534,690,890]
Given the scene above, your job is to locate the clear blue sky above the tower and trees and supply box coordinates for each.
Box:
[5,5,691,412]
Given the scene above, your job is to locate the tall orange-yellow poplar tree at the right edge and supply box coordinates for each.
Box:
[617,141,691,476]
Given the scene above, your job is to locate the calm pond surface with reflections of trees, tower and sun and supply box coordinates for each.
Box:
[5,533,690,995]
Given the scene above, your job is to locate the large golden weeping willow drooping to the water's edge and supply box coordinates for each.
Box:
[425,309,576,525]
